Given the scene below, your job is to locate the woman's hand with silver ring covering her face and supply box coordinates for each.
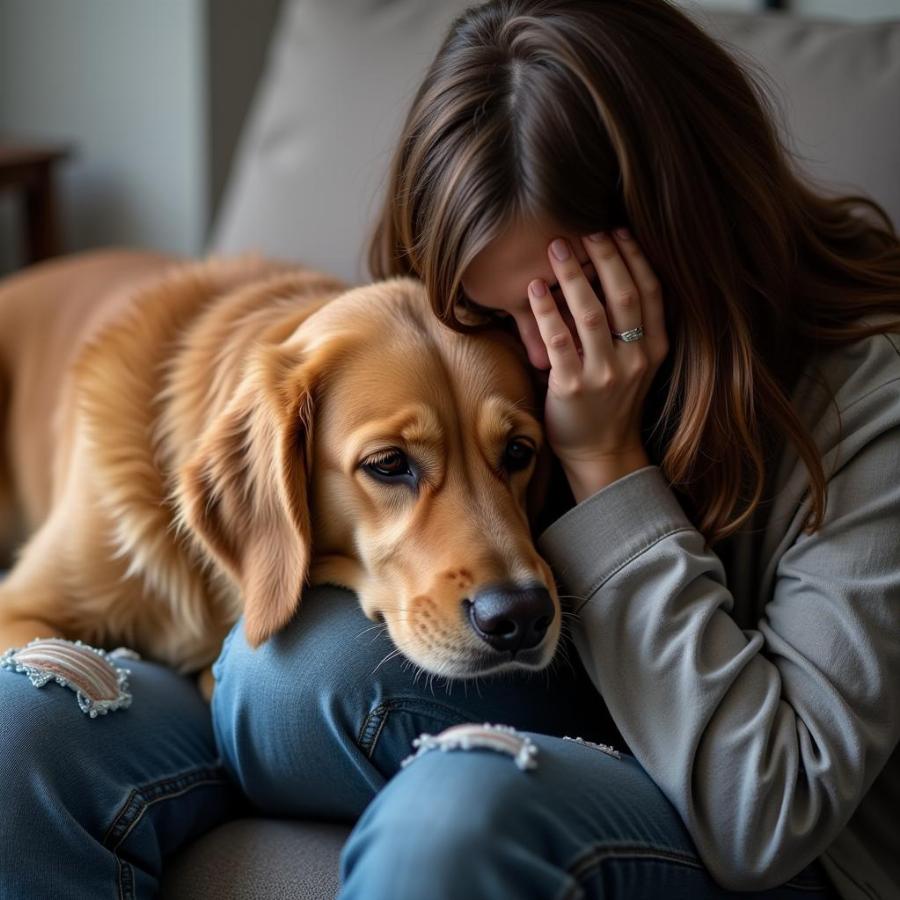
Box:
[528,229,669,502]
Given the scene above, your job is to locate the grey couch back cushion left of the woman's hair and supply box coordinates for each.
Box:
[210,0,471,282]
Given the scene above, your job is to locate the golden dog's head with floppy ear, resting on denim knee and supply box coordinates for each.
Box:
[182,278,560,677]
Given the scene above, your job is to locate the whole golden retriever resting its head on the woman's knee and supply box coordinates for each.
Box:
[0,250,561,677]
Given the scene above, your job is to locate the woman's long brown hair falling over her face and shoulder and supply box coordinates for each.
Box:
[368,0,900,543]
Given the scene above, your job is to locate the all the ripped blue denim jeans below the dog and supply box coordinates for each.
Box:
[0,587,829,900]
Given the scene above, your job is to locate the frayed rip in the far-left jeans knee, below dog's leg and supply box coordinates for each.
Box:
[0,638,139,719]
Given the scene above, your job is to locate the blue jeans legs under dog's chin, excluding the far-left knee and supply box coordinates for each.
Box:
[213,586,837,900]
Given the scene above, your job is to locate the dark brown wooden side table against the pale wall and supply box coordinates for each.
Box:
[0,138,72,264]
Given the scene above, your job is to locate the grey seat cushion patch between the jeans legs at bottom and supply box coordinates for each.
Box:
[159,818,350,900]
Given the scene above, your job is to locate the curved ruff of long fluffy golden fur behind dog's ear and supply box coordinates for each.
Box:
[63,254,343,652]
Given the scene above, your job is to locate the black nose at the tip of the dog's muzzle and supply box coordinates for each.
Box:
[467,587,554,654]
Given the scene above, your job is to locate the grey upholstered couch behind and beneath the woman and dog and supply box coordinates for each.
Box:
[162,0,900,900]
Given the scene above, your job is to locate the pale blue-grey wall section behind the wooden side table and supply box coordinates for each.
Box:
[0,0,209,269]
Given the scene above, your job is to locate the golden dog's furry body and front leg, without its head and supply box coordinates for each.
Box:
[0,250,352,669]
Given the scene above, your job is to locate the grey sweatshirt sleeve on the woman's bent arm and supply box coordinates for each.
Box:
[538,427,900,890]
